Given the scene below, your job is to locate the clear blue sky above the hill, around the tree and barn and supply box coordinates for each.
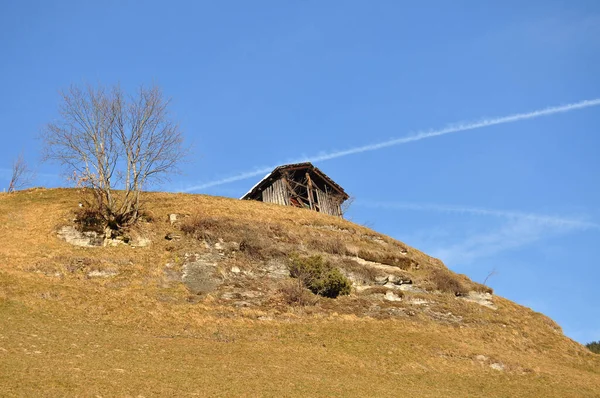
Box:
[0,0,600,342]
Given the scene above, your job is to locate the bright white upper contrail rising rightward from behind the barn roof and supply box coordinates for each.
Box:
[184,98,600,192]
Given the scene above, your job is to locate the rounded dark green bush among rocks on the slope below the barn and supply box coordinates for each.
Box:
[289,256,351,298]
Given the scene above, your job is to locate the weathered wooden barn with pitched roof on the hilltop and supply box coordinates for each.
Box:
[241,162,348,217]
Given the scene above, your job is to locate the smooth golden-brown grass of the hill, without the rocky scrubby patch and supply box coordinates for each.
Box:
[0,190,600,397]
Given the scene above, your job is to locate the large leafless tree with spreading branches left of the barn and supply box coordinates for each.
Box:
[42,86,187,230]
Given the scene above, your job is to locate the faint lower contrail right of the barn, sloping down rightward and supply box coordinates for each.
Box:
[355,201,600,230]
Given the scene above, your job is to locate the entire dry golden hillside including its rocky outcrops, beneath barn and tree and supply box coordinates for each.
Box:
[0,189,600,397]
